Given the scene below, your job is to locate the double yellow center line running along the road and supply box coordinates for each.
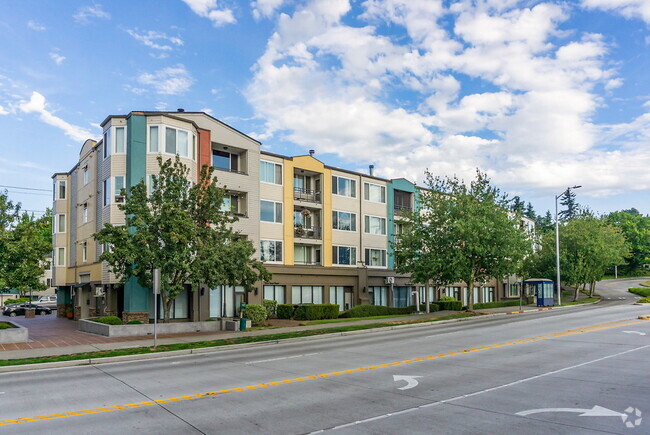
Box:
[0,320,648,426]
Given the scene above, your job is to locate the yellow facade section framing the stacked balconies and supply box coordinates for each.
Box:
[282,156,332,267]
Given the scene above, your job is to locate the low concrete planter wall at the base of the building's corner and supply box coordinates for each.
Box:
[79,319,221,337]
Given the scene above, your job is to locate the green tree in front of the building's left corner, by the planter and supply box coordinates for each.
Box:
[95,156,270,322]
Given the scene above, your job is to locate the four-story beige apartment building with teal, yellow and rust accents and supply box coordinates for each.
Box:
[52,109,520,321]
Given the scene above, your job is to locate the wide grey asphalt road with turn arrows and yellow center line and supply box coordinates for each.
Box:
[0,282,650,434]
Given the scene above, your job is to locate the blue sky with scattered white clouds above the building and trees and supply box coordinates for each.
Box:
[0,0,650,218]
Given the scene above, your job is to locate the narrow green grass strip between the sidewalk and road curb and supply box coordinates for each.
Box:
[0,313,474,366]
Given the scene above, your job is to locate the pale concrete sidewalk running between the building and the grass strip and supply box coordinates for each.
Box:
[0,305,576,359]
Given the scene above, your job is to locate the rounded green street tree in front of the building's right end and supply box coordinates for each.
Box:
[397,170,531,310]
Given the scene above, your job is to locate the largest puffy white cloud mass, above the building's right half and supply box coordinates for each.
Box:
[246,0,650,195]
